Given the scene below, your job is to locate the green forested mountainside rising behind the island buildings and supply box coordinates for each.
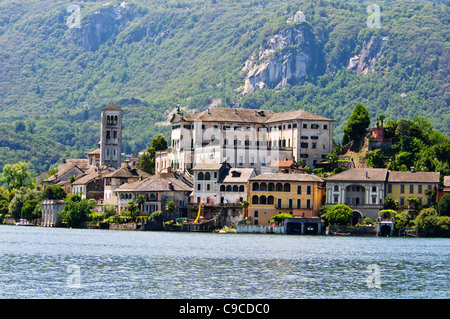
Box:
[0,0,450,175]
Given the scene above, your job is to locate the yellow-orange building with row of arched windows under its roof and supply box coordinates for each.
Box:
[248,173,325,225]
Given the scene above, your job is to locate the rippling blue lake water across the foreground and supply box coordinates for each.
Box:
[0,225,450,299]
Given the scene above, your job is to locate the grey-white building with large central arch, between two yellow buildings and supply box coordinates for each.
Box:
[325,168,388,224]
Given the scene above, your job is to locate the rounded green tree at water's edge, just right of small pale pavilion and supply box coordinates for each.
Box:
[59,194,96,227]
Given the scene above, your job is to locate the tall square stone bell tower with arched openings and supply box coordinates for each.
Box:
[100,103,122,168]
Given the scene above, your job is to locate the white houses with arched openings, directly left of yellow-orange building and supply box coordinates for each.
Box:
[193,161,256,207]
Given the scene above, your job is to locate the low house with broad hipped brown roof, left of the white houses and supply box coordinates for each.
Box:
[114,171,192,217]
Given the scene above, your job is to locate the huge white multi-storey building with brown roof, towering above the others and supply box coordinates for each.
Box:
[155,108,334,174]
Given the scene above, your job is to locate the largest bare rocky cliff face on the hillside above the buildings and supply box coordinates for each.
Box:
[242,23,317,94]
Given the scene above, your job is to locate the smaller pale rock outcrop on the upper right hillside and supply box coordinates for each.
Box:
[347,36,389,74]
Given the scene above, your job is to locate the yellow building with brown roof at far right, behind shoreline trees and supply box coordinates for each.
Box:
[386,171,440,208]
